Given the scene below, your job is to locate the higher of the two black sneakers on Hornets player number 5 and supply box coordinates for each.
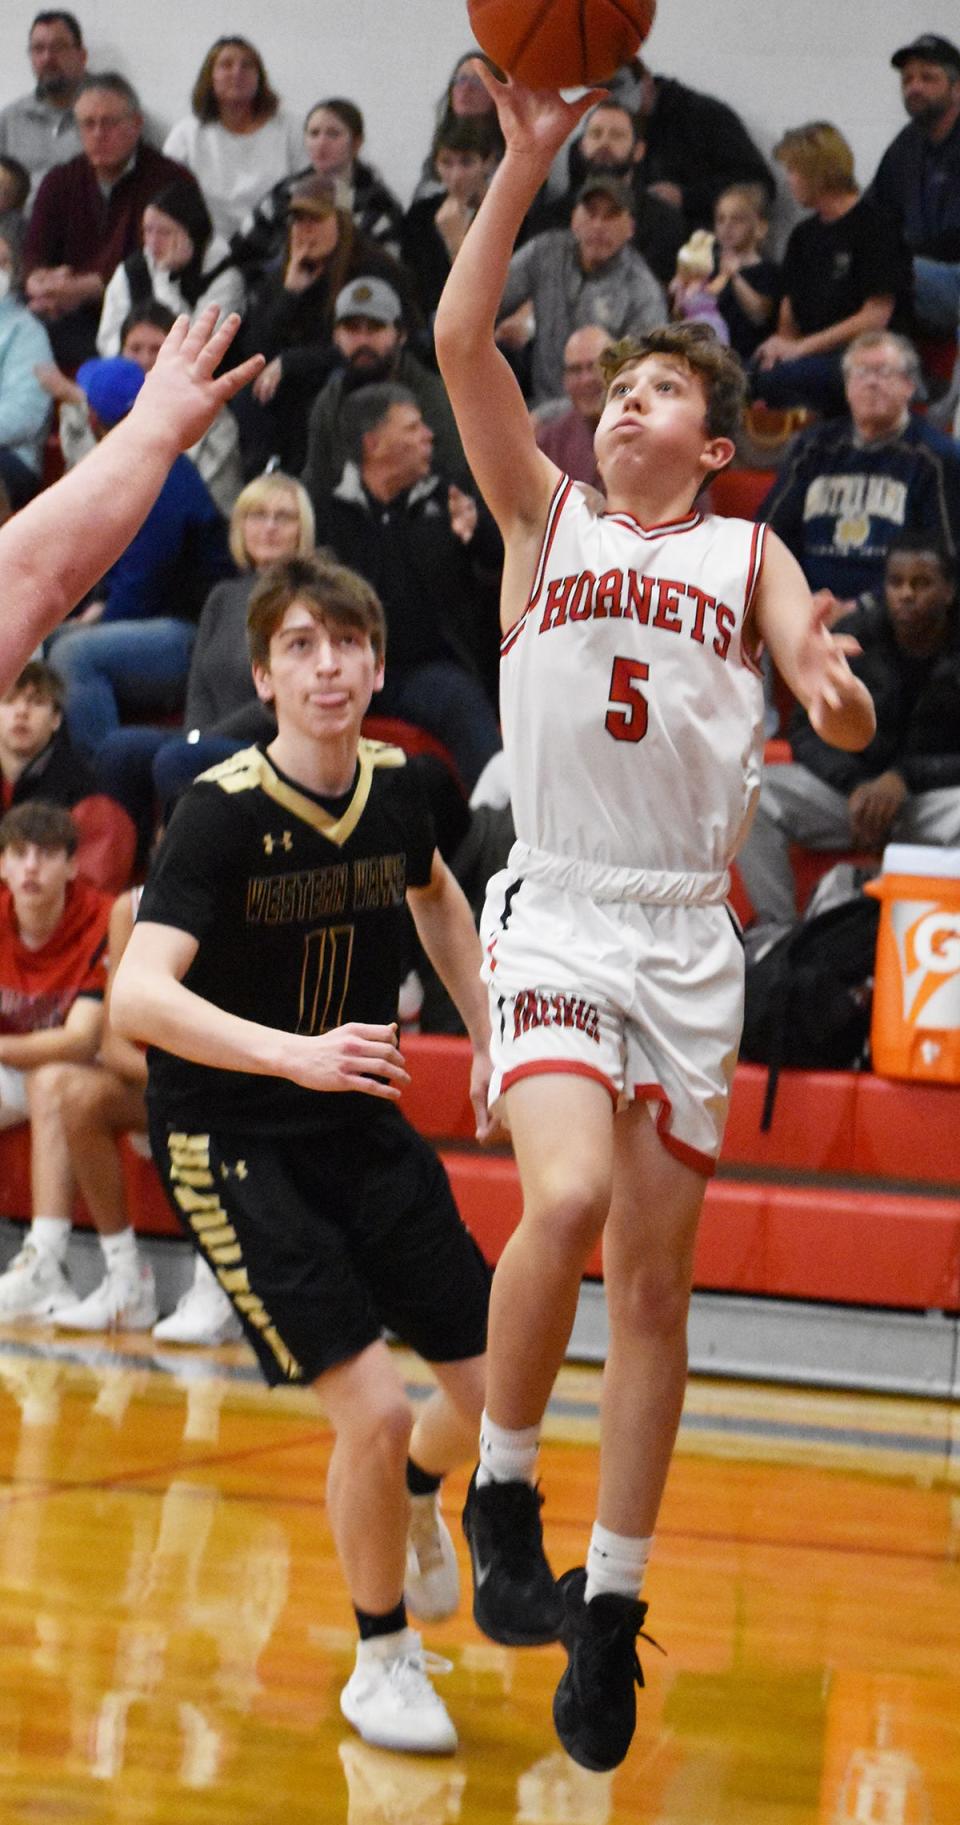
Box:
[464,1471,564,1648]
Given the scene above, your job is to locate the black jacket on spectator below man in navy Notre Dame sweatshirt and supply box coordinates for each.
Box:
[788,595,960,794]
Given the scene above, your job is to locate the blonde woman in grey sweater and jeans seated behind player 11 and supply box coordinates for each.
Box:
[97,469,314,852]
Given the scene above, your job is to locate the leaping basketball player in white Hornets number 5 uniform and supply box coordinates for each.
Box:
[434,71,874,1768]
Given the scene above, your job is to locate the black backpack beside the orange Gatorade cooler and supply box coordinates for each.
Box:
[741,892,880,1132]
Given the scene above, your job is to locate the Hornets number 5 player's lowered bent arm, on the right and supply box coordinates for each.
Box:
[756,529,876,752]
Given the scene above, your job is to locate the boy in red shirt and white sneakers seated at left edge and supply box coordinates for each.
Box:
[0,799,111,1318]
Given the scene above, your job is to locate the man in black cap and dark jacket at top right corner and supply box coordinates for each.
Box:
[869,31,960,336]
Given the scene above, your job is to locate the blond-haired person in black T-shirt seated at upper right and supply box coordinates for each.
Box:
[752,120,909,416]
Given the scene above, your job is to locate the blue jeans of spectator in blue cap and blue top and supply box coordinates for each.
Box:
[49,615,197,754]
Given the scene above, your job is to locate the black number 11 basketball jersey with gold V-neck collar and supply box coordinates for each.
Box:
[139,741,434,1133]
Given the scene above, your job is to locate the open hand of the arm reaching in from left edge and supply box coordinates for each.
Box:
[130,305,263,451]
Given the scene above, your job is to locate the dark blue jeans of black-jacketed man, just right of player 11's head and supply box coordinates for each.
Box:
[370,655,504,796]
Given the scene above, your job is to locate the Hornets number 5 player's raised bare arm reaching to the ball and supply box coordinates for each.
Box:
[434,62,597,548]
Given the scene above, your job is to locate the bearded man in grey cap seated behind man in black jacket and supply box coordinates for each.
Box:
[301,274,473,502]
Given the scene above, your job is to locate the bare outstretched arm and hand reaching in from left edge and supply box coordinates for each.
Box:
[0,307,263,690]
